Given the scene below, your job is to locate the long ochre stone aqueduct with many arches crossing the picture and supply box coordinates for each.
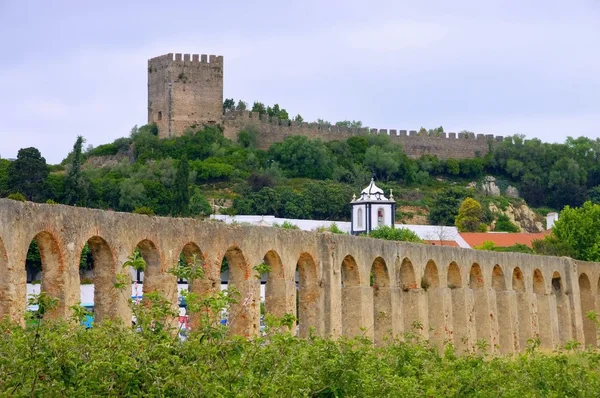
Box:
[0,199,600,353]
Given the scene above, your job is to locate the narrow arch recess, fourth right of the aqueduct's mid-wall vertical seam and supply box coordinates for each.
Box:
[421,260,446,348]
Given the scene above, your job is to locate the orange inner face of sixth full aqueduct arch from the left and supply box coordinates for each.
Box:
[263,250,296,317]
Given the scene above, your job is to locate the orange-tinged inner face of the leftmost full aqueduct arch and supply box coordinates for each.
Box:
[33,231,67,318]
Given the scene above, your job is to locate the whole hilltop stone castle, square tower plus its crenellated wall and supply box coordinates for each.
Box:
[148,54,503,159]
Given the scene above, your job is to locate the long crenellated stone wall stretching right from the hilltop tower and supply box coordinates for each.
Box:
[223,111,503,159]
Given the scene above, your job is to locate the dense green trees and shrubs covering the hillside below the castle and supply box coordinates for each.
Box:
[0,121,600,230]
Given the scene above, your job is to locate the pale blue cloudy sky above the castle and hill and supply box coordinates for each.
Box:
[0,0,600,163]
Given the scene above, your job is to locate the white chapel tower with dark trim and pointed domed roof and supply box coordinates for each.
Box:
[350,179,396,235]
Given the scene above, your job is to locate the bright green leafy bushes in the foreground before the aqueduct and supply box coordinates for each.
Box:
[0,262,600,397]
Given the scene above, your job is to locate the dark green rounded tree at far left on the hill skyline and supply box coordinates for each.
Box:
[7,147,48,202]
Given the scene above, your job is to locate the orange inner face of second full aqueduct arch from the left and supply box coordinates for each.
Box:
[82,235,126,324]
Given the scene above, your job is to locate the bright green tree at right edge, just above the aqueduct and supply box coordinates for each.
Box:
[552,202,600,261]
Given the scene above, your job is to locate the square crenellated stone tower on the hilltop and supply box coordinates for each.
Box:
[148,53,223,138]
